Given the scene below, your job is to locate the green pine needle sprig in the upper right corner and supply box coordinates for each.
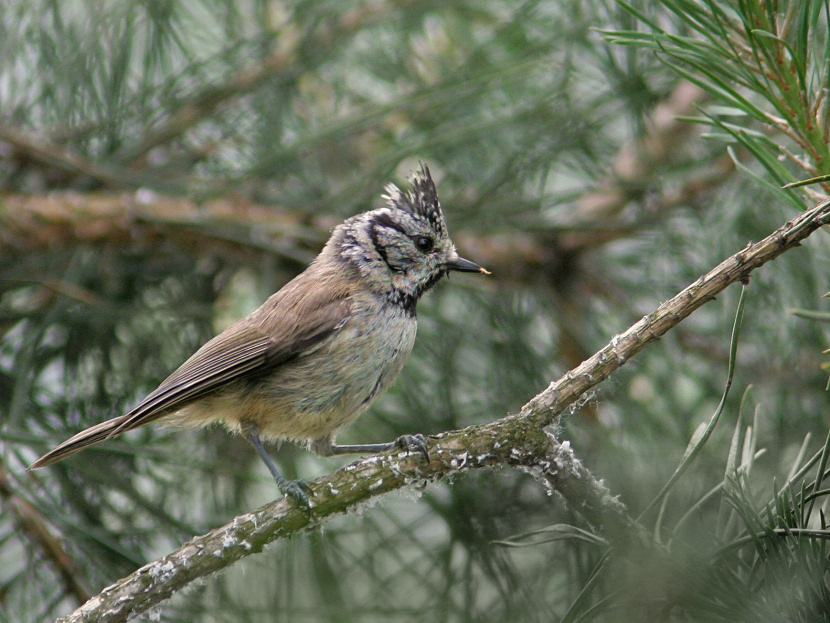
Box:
[604,0,830,195]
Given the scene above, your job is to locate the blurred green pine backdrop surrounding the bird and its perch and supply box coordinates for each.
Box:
[0,0,830,622]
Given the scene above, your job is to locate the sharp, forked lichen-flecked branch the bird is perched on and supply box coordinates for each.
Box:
[55,200,830,623]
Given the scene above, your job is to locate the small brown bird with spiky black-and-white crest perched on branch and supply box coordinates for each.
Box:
[29,163,490,505]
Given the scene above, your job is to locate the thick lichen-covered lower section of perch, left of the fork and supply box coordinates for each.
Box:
[59,422,556,623]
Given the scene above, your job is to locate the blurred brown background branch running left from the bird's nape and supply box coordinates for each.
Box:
[0,191,324,263]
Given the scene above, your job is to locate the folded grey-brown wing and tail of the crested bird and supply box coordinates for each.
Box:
[31,282,351,468]
